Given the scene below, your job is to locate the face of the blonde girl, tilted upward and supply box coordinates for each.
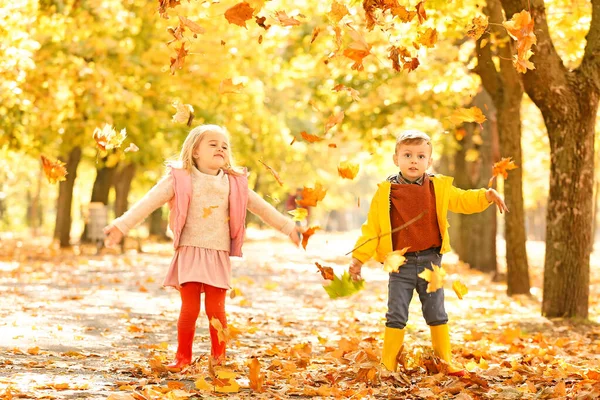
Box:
[192,131,229,175]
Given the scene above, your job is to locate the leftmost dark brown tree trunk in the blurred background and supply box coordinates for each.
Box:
[54,147,81,248]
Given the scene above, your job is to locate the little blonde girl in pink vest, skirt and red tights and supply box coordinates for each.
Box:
[104,125,299,370]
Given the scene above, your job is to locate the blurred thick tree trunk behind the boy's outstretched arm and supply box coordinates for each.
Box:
[455,89,497,273]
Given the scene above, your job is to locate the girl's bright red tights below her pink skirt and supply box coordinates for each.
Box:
[176,282,227,364]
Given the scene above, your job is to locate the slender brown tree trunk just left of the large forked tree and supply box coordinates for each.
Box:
[475,0,531,296]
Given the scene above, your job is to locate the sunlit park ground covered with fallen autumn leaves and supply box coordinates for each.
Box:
[0,231,600,400]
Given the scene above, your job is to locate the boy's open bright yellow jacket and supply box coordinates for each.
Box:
[352,175,492,263]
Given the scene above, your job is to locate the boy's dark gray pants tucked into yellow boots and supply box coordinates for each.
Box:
[385,249,448,329]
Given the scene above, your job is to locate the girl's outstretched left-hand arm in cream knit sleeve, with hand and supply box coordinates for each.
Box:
[104,175,175,246]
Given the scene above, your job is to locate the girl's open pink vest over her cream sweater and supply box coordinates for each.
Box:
[169,168,248,257]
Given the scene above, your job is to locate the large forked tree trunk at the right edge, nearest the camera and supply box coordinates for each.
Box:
[501,0,600,318]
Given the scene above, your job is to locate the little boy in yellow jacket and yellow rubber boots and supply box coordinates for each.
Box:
[350,130,508,375]
